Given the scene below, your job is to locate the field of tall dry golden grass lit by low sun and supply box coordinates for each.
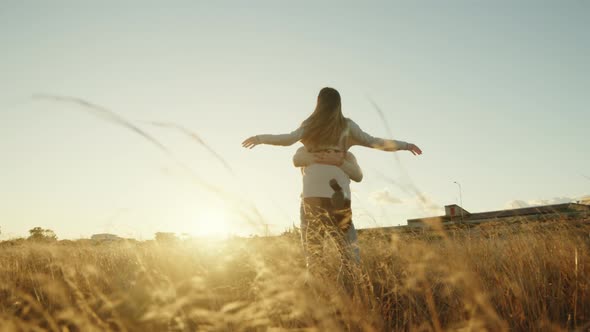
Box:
[0,221,590,331]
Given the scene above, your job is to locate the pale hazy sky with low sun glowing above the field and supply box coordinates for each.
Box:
[0,1,590,238]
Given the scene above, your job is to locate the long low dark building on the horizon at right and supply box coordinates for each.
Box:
[408,203,590,227]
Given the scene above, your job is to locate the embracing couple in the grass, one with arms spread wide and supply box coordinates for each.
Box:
[242,87,422,280]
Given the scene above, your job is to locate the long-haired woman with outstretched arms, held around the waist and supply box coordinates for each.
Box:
[242,87,422,286]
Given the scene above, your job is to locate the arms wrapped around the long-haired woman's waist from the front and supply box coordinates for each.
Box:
[293,147,363,182]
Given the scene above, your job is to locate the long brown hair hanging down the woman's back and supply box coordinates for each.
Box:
[301,88,347,148]
